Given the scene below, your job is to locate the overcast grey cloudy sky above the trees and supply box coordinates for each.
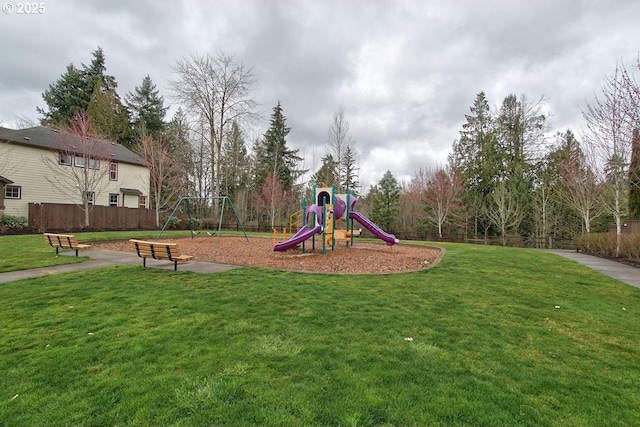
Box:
[0,0,640,188]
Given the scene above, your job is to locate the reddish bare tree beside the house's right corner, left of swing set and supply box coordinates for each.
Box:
[134,136,183,227]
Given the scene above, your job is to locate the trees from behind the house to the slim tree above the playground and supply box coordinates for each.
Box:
[38,48,358,231]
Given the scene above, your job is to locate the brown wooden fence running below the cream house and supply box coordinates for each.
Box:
[29,203,158,233]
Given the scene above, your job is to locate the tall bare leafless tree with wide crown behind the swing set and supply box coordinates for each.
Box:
[169,53,258,216]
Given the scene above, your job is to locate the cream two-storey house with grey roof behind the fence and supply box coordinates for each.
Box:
[0,126,150,218]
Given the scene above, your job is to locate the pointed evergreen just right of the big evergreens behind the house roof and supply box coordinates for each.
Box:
[125,75,167,138]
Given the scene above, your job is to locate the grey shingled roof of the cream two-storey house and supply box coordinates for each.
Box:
[0,126,147,167]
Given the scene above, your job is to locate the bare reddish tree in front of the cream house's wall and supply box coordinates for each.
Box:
[42,111,111,227]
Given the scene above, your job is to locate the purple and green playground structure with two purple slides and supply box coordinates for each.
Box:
[273,186,400,253]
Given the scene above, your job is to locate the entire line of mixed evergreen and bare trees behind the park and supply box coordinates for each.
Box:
[38,48,640,247]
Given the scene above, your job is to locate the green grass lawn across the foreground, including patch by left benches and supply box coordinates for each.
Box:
[0,234,640,426]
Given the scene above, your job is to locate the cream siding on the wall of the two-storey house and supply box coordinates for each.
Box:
[2,144,149,217]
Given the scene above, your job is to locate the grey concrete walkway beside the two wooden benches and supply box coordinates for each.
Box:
[0,249,238,283]
